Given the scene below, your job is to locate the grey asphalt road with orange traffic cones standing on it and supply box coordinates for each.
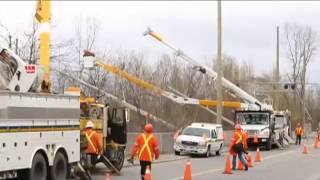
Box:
[88,145,320,180]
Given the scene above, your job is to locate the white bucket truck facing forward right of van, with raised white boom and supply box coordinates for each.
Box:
[143,28,291,150]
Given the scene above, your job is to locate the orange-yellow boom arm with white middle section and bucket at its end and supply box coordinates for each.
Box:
[84,51,245,109]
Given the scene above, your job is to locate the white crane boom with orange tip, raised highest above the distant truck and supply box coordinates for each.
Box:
[144,28,272,109]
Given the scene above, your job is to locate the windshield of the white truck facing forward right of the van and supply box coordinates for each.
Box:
[237,113,269,125]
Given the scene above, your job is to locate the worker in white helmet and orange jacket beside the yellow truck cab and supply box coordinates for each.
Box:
[84,121,103,168]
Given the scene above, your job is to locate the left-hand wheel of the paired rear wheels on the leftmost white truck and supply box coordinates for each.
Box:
[18,153,48,180]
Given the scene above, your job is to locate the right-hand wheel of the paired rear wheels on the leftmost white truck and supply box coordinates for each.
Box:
[50,152,69,180]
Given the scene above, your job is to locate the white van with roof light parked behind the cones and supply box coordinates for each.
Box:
[173,123,223,157]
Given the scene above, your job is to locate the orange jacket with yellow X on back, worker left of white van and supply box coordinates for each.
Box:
[131,133,160,162]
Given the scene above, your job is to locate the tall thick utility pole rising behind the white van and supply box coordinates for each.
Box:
[217,0,223,124]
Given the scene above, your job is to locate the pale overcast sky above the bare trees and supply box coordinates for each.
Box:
[0,1,320,82]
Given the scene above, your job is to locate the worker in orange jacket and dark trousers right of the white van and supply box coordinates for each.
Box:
[229,124,248,171]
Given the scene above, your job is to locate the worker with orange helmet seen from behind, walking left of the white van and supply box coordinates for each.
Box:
[128,124,160,180]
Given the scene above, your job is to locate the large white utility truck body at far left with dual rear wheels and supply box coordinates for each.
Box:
[0,47,80,180]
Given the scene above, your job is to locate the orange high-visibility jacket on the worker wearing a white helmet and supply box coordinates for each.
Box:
[84,129,102,154]
